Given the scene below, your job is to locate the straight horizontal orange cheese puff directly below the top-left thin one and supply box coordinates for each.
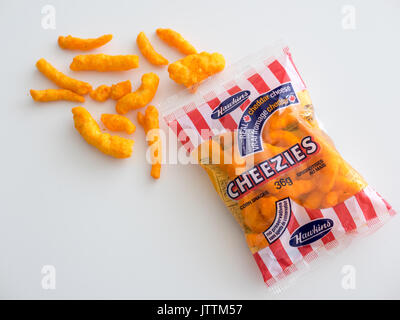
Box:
[69,53,139,72]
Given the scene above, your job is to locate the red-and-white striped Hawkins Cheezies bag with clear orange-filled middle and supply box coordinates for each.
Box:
[163,45,395,289]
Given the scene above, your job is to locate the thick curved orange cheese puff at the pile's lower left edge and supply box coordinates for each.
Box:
[72,107,134,158]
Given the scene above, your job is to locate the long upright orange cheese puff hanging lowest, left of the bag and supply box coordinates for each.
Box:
[137,106,161,179]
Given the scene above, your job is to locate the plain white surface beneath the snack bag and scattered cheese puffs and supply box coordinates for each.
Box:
[0,0,400,299]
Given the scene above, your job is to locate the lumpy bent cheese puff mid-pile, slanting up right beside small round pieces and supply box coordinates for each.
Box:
[115,72,160,114]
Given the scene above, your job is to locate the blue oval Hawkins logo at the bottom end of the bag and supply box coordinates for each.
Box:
[289,218,333,247]
